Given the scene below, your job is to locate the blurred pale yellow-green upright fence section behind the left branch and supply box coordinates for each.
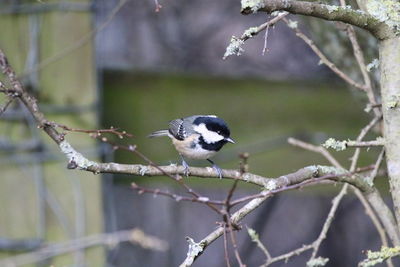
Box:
[0,0,103,266]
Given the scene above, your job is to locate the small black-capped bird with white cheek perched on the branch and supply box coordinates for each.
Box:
[148,115,235,178]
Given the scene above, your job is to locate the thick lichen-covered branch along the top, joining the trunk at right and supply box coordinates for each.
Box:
[241,0,394,40]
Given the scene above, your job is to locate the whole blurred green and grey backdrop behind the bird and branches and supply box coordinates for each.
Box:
[0,0,387,267]
